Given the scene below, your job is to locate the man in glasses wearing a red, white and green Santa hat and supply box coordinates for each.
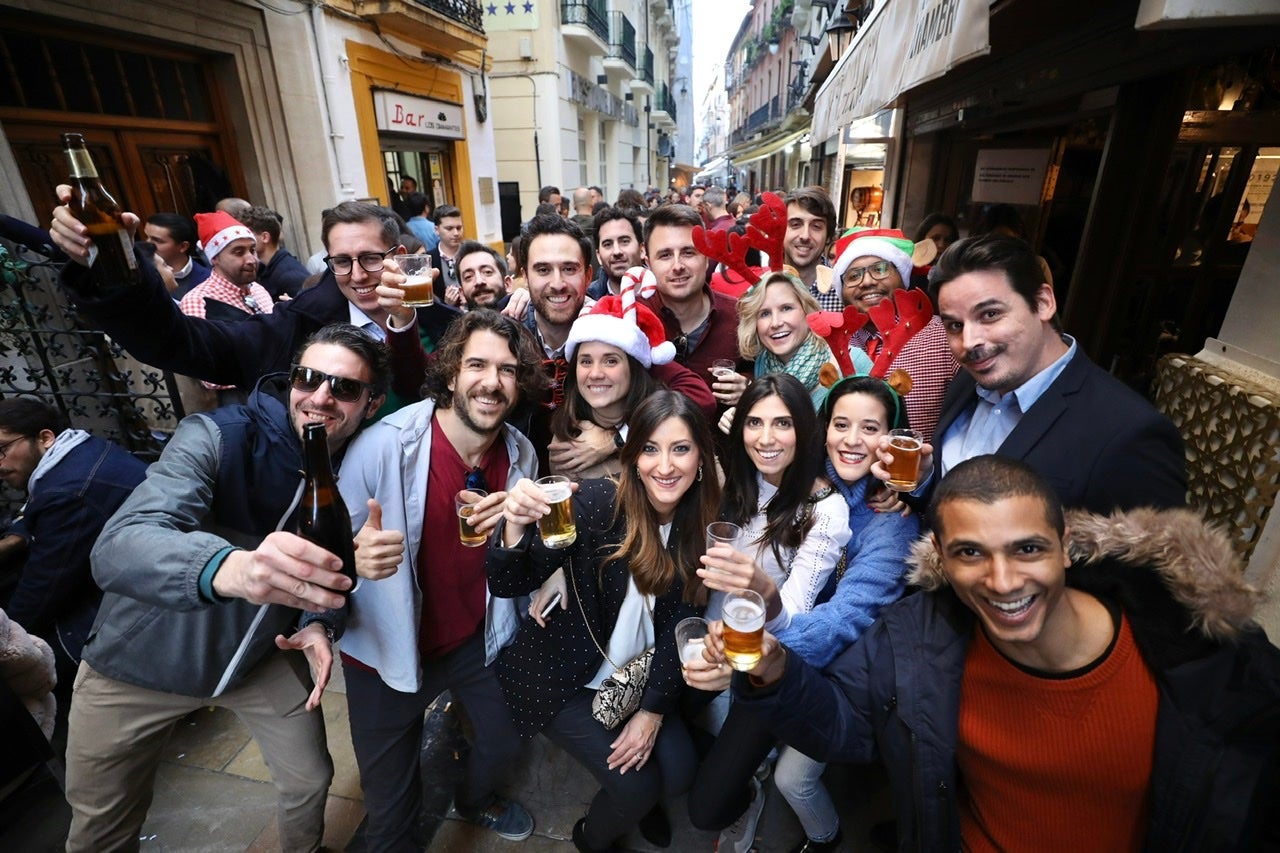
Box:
[834,225,960,441]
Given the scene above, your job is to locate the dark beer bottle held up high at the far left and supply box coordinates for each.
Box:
[63,133,138,288]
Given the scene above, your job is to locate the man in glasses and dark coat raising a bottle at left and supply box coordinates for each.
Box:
[50,197,442,397]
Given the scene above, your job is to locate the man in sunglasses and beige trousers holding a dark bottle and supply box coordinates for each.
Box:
[67,324,387,850]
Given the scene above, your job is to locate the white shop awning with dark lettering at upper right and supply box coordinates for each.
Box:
[813,0,991,141]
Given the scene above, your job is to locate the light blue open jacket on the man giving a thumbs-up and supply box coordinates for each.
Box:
[338,400,538,693]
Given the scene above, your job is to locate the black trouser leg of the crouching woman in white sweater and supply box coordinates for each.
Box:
[689,702,777,831]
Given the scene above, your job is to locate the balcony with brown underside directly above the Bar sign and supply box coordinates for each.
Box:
[324,0,489,56]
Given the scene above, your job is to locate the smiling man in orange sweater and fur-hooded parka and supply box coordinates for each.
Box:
[709,456,1280,852]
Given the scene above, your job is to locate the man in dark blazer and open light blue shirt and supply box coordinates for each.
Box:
[881,234,1187,514]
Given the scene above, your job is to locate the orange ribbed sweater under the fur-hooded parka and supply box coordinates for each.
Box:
[956,619,1157,853]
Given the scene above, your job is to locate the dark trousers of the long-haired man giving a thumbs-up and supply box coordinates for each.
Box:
[346,631,521,852]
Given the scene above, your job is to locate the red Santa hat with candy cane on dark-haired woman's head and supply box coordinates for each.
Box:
[564,266,676,368]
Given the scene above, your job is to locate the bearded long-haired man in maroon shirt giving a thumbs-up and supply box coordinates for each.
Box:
[338,307,543,850]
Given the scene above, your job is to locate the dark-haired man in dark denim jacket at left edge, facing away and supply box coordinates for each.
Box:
[0,397,147,738]
